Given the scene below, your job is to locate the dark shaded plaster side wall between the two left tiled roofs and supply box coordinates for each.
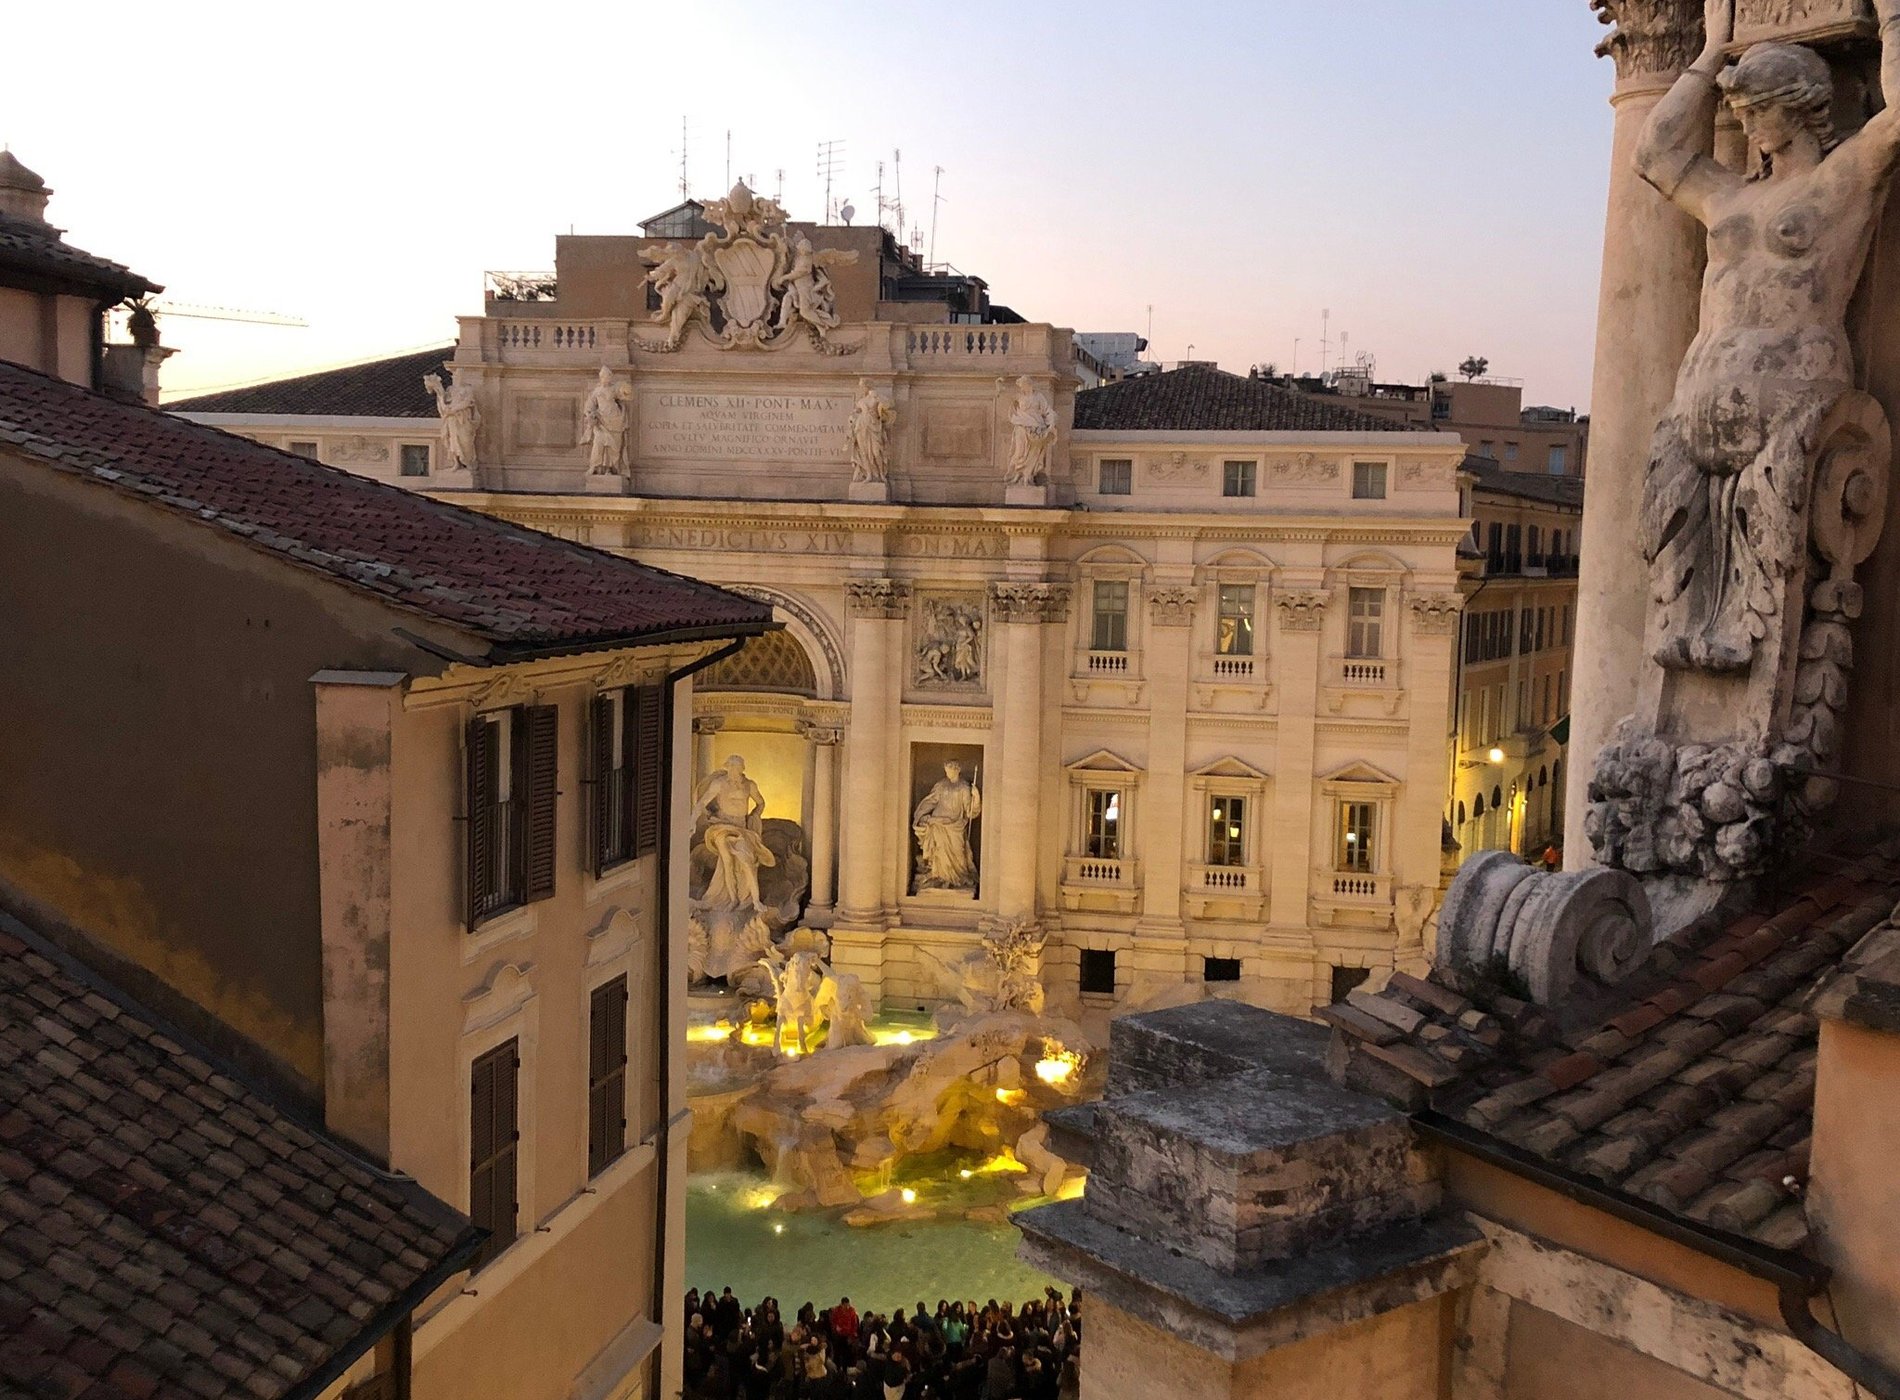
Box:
[0,454,440,1094]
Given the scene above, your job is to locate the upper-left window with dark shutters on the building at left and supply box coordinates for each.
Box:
[466,705,559,927]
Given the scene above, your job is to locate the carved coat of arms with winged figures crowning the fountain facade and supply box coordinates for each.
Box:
[635,180,863,355]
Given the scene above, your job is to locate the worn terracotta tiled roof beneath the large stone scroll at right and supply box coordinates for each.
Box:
[1317,849,1900,1250]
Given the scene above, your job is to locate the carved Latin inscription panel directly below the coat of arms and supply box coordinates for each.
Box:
[640,393,851,464]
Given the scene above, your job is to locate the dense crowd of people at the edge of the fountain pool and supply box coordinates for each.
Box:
[684,1288,1081,1400]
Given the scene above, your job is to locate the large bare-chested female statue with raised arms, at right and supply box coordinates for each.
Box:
[1636,0,1900,672]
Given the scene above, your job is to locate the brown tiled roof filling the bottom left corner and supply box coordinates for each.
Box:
[0,921,483,1400]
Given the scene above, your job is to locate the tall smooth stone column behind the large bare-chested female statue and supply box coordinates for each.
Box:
[1564,0,1714,870]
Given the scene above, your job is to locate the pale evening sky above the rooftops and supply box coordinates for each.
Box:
[0,0,1611,408]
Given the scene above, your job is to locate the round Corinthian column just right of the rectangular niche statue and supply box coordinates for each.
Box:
[984,583,1068,923]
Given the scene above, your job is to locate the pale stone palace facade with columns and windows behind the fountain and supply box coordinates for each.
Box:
[175,202,1467,1012]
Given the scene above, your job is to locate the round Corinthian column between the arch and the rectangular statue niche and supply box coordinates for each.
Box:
[832,579,910,957]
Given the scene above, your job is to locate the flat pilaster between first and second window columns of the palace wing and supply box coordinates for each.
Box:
[1134,585,1193,938]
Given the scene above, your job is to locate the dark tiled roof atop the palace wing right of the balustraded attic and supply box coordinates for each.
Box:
[1075,365,1433,433]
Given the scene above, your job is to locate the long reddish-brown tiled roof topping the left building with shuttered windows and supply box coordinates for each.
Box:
[0,361,771,659]
